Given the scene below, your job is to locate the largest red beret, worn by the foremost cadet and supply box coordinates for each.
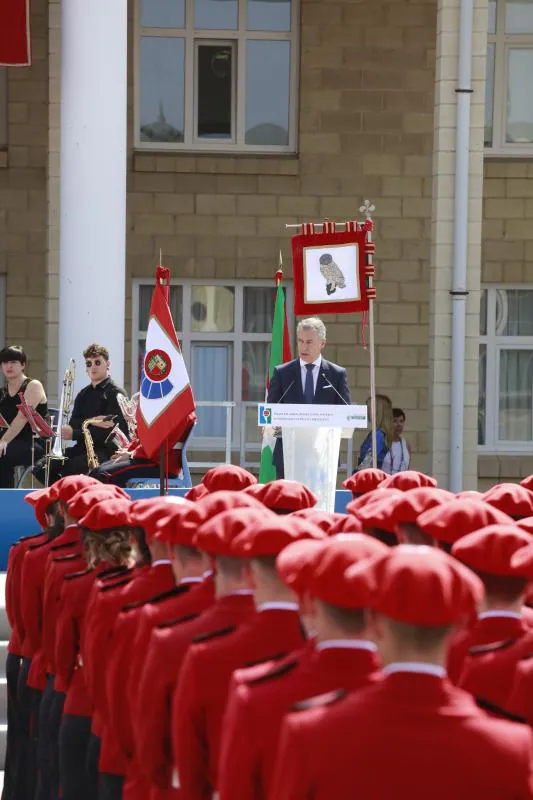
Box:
[346,544,484,627]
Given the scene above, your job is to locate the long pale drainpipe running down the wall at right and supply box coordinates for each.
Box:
[449,0,474,492]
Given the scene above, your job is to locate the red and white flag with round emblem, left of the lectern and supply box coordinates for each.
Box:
[137,267,195,461]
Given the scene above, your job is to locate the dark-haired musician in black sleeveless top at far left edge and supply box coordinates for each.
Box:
[0,345,48,489]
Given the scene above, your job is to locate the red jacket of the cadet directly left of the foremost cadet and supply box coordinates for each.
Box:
[218,642,379,800]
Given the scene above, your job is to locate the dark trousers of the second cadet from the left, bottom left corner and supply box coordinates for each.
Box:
[14,658,42,800]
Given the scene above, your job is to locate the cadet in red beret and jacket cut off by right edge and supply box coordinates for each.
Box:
[452,524,533,713]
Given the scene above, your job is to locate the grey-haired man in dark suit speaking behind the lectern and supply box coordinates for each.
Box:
[267,317,351,479]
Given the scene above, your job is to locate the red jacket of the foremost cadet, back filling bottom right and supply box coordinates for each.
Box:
[270,672,533,800]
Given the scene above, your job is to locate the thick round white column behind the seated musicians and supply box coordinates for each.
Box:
[59,0,128,389]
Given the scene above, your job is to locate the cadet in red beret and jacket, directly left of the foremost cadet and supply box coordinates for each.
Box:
[219,534,386,800]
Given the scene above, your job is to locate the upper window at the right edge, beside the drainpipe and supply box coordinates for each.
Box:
[485,0,533,155]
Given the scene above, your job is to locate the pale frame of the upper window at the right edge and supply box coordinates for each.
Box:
[485,0,533,158]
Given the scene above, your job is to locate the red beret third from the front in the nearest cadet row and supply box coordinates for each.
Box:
[232,514,326,558]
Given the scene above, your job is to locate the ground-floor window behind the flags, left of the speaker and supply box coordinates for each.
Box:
[132,281,292,453]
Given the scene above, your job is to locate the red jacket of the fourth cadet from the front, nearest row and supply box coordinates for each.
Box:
[134,594,255,797]
